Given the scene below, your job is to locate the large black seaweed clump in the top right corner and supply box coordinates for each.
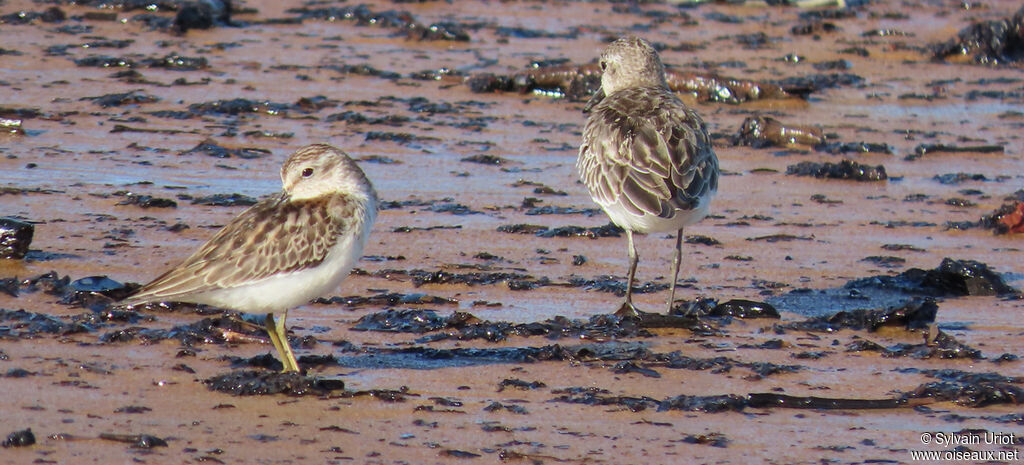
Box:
[932,7,1024,65]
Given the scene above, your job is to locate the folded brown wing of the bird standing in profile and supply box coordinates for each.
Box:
[125,194,350,304]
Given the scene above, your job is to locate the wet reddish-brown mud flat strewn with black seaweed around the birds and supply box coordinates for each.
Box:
[0,1,1024,463]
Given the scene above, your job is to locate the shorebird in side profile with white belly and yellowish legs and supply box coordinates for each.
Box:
[121,144,377,372]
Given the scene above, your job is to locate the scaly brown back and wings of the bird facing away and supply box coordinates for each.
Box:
[577,87,718,217]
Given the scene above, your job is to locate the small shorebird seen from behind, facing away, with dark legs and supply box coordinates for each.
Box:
[577,37,719,315]
